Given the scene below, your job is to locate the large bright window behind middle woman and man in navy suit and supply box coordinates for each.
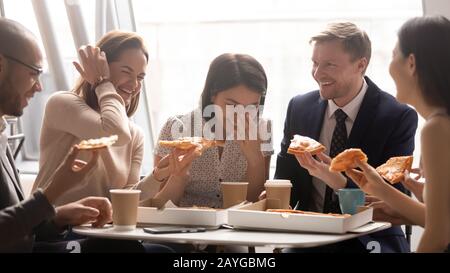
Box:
[133,0,422,170]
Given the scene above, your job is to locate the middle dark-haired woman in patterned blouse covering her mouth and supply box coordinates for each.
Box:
[155,53,273,208]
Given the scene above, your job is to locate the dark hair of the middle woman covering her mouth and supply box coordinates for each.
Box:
[201,53,267,119]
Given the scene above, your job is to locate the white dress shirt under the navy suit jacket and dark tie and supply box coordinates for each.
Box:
[310,79,369,212]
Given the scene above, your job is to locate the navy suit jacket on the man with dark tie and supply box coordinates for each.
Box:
[275,77,417,252]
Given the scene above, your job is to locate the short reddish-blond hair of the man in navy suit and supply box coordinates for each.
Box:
[309,22,372,71]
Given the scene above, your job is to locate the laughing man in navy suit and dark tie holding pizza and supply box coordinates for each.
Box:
[275,23,417,252]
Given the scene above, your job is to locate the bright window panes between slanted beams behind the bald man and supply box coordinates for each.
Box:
[3,0,95,173]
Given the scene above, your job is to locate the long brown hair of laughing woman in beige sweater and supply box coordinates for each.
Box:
[73,30,148,117]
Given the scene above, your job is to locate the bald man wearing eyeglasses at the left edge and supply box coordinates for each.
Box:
[0,18,111,252]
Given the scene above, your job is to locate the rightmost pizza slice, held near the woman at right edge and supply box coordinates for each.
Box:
[376,156,413,184]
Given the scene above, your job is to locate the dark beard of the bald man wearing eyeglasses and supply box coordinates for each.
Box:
[0,75,23,117]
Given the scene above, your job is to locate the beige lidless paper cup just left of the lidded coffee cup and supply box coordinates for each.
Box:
[264,179,292,209]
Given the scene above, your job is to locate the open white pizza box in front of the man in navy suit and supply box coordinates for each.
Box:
[228,199,373,234]
